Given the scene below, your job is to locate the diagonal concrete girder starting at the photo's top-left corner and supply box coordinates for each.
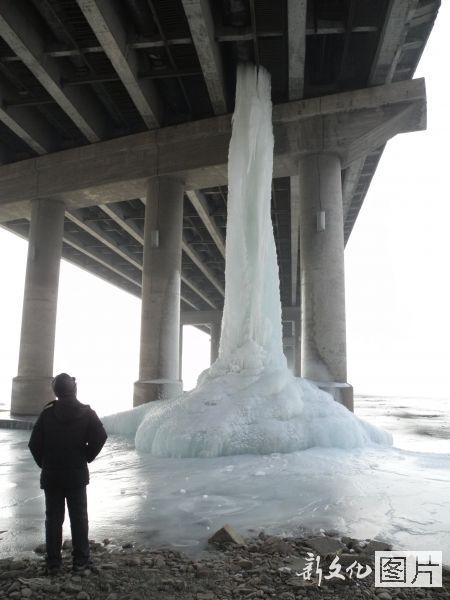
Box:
[0,0,103,142]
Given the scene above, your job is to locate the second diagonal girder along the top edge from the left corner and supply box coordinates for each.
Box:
[77,0,161,129]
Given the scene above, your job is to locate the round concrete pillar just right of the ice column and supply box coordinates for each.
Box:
[299,153,353,410]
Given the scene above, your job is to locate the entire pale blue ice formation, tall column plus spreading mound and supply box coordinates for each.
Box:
[104,65,392,458]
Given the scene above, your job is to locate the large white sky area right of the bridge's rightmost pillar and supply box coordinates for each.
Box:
[346,2,450,398]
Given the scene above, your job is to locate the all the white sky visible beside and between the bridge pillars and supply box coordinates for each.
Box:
[0,2,450,414]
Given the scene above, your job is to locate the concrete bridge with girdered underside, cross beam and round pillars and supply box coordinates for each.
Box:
[0,0,439,414]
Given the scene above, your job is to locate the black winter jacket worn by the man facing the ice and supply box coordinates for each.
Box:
[28,396,108,488]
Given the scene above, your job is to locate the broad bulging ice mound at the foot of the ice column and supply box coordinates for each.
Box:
[104,369,392,458]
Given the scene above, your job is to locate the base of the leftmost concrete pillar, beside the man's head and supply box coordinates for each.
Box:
[11,376,55,416]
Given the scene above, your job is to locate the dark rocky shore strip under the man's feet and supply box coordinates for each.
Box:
[0,528,450,600]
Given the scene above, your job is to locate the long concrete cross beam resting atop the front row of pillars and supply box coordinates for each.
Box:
[0,78,425,221]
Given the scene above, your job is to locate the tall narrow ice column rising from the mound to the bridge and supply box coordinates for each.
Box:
[214,65,286,372]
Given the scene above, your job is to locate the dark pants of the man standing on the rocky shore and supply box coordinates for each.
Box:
[44,485,89,567]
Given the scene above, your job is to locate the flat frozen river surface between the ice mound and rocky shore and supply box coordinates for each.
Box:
[0,398,450,564]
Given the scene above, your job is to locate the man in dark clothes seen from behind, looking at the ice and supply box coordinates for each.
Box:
[28,373,107,575]
